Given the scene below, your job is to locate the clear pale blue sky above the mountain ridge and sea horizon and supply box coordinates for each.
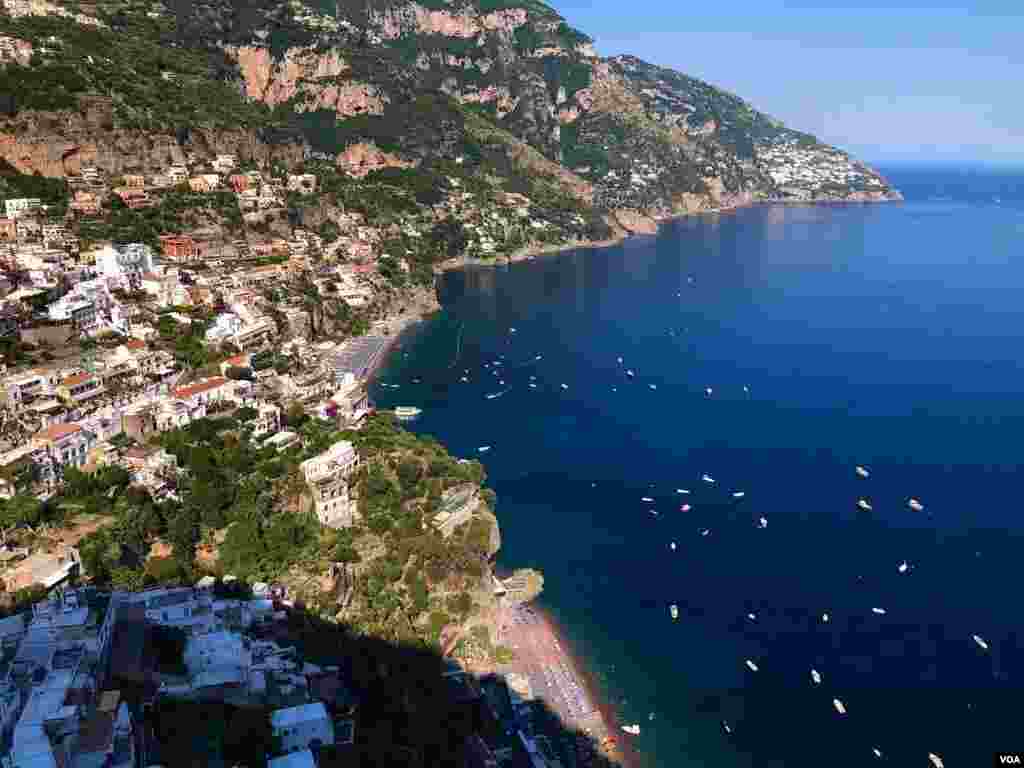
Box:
[552,0,1024,165]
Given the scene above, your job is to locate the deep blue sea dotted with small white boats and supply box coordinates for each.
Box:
[372,167,1024,768]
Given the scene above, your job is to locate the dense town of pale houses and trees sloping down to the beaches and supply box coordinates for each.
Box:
[0,156,573,768]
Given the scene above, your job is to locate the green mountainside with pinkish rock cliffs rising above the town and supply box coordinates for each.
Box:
[0,0,898,256]
